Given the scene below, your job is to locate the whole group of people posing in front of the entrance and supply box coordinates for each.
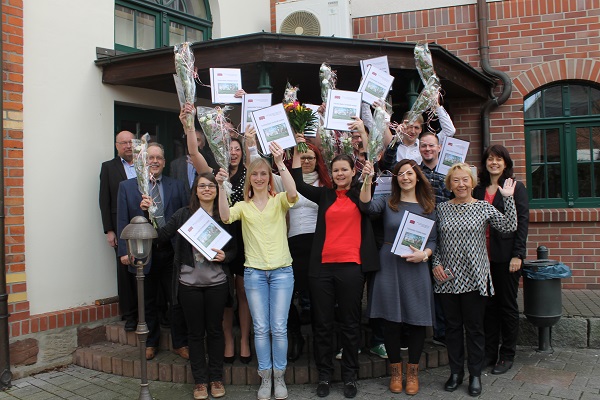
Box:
[100,94,529,400]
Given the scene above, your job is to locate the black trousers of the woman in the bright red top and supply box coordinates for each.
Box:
[309,263,365,382]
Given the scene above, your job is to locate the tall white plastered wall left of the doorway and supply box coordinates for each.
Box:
[23,0,178,314]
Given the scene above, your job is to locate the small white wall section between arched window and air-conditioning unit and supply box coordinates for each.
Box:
[209,0,271,39]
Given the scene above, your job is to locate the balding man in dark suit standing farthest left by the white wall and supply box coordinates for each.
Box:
[100,131,137,331]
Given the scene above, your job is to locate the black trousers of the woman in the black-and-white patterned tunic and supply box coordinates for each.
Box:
[440,291,487,376]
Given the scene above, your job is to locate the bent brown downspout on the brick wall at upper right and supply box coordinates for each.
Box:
[477,0,512,149]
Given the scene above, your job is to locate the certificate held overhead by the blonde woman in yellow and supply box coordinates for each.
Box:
[252,103,296,154]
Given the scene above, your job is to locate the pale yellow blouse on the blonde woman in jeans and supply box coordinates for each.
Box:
[224,192,298,270]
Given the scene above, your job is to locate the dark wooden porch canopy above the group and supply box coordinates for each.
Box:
[96,32,494,104]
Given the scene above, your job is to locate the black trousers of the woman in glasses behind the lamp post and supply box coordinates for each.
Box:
[179,282,229,384]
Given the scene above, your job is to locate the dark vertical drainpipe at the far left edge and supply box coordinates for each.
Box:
[0,27,12,390]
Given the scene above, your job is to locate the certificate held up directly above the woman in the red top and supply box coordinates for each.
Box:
[325,89,362,131]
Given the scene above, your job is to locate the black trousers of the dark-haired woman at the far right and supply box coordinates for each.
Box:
[484,262,521,361]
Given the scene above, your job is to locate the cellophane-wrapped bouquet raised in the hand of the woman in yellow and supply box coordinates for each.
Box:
[196,107,232,202]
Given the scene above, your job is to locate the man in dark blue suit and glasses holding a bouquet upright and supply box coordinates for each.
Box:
[117,143,189,360]
